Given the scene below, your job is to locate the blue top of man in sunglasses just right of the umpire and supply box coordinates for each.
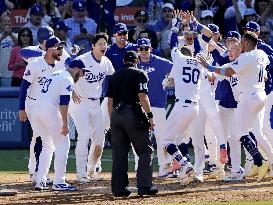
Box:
[138,54,173,108]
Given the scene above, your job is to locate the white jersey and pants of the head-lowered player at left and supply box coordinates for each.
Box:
[31,70,74,184]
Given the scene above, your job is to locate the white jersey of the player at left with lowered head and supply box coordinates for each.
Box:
[37,70,74,110]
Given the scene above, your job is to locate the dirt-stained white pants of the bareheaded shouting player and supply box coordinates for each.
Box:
[69,98,104,177]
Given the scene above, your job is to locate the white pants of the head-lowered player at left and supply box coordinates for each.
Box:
[32,106,70,184]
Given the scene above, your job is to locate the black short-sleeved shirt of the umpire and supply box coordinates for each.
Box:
[106,67,148,106]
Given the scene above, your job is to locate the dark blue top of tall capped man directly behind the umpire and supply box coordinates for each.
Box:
[105,43,137,71]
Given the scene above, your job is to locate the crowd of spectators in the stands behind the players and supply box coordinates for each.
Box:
[0,0,273,87]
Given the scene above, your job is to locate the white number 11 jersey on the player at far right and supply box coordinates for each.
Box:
[229,49,270,94]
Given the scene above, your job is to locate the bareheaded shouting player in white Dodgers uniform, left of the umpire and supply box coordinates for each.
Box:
[69,33,114,183]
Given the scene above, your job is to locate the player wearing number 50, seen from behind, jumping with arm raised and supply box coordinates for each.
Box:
[161,11,204,184]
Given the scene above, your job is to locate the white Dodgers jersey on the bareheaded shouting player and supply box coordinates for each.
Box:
[74,51,114,99]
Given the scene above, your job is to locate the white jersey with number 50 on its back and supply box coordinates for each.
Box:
[169,48,204,102]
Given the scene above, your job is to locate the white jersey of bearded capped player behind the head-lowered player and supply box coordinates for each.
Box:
[23,56,64,104]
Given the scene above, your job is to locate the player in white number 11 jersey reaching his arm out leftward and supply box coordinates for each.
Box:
[199,32,269,182]
